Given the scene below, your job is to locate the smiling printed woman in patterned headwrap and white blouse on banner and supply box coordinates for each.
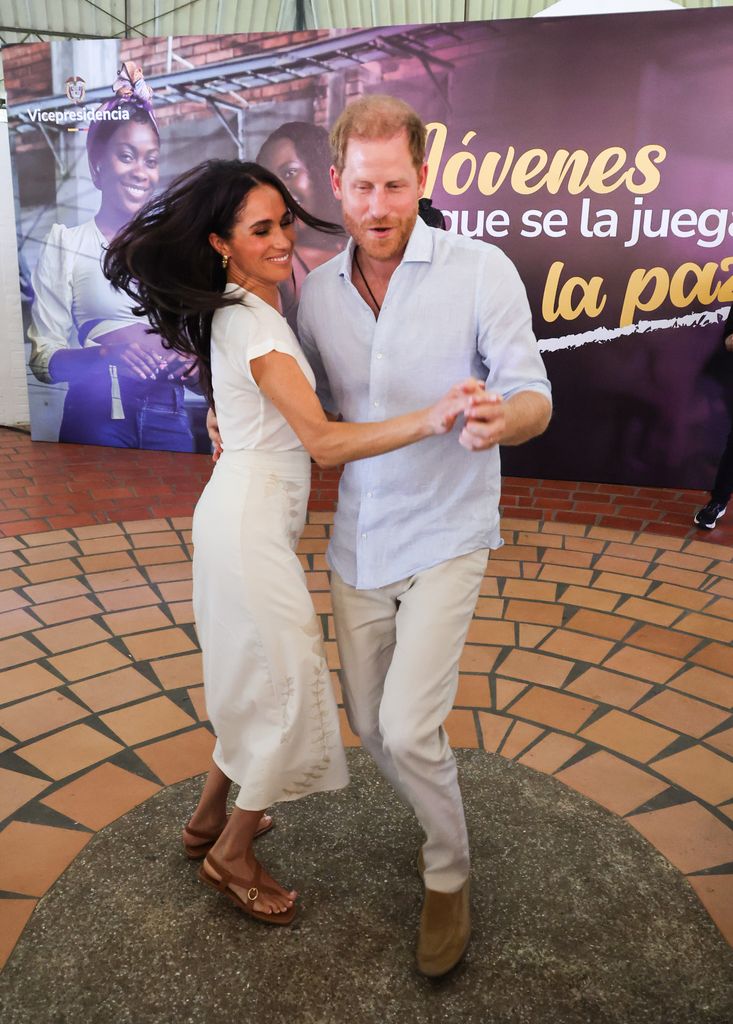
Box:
[29,61,193,452]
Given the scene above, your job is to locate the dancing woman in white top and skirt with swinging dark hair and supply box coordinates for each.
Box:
[104,161,479,925]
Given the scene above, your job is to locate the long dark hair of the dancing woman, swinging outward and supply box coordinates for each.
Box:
[103,160,343,401]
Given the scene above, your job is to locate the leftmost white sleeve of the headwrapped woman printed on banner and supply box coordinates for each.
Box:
[28,224,74,384]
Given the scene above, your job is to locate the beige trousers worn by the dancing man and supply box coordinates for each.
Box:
[331,548,488,892]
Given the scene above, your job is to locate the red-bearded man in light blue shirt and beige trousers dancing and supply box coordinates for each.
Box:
[298,95,552,977]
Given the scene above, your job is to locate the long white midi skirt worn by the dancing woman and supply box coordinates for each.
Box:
[193,451,348,811]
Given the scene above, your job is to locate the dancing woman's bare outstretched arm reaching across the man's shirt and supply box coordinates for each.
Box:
[250,351,472,469]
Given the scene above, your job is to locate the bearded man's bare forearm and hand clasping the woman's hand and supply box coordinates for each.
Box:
[459,391,552,452]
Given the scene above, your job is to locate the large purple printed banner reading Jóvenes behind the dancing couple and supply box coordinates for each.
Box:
[4,9,733,488]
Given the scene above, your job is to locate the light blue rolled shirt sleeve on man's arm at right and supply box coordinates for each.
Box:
[476,246,552,401]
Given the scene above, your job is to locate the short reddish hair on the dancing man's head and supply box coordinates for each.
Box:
[331,93,427,174]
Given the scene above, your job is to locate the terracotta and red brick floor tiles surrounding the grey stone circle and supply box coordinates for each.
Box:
[0,430,733,963]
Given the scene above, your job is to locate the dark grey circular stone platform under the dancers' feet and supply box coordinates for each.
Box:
[0,751,733,1024]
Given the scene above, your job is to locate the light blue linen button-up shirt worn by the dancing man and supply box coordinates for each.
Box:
[298,219,551,590]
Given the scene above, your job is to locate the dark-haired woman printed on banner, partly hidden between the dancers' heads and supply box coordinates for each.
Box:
[257,121,344,307]
